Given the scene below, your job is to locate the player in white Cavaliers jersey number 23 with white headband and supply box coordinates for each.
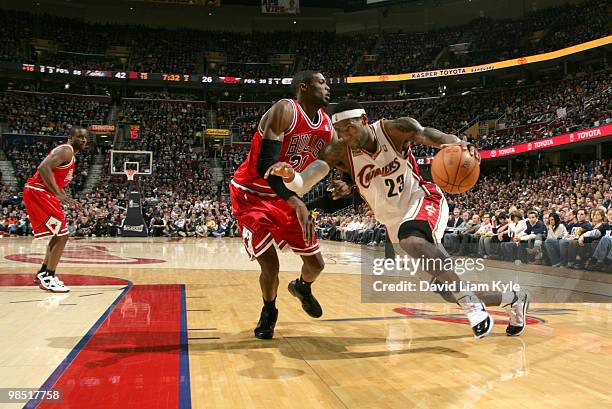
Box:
[268,100,529,338]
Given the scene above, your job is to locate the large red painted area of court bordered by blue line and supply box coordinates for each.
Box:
[38,285,182,409]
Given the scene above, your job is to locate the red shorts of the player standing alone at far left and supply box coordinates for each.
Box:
[23,186,68,239]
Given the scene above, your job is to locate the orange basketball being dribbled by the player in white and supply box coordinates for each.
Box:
[431,145,480,194]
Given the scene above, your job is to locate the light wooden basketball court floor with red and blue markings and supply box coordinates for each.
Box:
[0,238,612,409]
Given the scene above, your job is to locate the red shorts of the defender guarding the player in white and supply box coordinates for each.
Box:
[230,180,321,259]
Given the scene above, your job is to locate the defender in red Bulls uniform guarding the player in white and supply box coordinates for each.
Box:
[230,71,334,339]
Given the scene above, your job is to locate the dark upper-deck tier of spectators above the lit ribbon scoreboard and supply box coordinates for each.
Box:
[0,0,610,77]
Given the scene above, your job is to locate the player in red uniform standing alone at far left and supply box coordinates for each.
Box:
[23,127,87,293]
